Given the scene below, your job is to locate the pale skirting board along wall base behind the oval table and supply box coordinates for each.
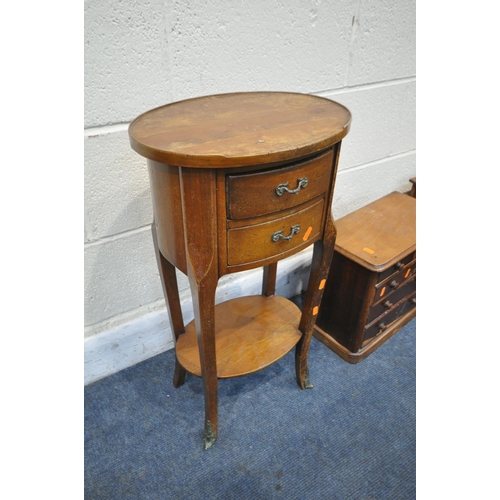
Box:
[84,247,312,385]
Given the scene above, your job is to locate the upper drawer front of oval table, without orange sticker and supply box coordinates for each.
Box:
[227,150,333,219]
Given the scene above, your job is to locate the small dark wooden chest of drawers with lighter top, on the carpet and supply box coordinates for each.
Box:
[314,192,416,363]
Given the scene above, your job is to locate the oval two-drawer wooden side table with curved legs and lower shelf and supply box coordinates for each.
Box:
[129,92,351,448]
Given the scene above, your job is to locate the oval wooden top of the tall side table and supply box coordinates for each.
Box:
[129,92,351,168]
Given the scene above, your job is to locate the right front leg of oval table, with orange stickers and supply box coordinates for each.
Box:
[295,213,336,389]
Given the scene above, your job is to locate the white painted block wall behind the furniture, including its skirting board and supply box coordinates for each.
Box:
[84,0,416,383]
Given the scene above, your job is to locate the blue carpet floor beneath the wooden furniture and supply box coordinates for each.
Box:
[85,310,416,500]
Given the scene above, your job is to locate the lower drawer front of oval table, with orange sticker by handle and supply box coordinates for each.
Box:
[227,199,325,266]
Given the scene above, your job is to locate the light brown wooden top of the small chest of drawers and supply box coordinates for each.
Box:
[335,192,416,270]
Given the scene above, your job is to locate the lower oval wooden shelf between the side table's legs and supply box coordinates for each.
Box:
[176,295,302,378]
